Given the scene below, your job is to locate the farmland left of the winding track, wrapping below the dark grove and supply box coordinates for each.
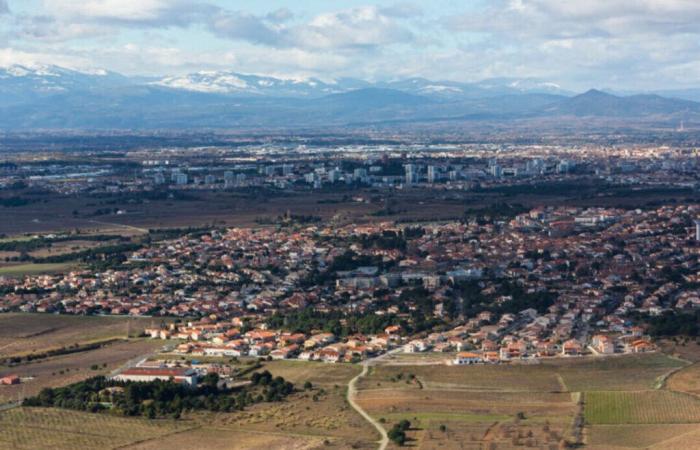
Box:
[0,361,378,450]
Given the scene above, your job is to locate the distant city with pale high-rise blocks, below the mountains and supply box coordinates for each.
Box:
[0,144,700,195]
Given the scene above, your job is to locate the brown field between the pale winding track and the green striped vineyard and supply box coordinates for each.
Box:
[358,358,576,449]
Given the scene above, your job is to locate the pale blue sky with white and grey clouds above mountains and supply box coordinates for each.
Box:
[0,0,700,90]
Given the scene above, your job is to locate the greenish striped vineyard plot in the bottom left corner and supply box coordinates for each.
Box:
[0,408,196,450]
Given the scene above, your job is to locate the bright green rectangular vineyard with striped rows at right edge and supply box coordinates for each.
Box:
[585,391,700,425]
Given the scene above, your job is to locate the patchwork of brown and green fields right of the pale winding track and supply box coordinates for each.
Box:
[352,353,700,449]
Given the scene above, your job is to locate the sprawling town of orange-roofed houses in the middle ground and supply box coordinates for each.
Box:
[0,200,700,361]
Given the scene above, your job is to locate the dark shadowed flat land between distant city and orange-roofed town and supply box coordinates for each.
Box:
[0,188,693,235]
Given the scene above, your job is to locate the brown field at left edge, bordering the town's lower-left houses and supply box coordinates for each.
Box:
[0,313,160,359]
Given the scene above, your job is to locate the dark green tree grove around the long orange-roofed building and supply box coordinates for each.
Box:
[23,371,294,419]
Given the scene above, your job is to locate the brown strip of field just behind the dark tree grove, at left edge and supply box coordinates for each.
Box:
[0,339,162,403]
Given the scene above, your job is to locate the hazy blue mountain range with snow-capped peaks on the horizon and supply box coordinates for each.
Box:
[0,66,700,130]
